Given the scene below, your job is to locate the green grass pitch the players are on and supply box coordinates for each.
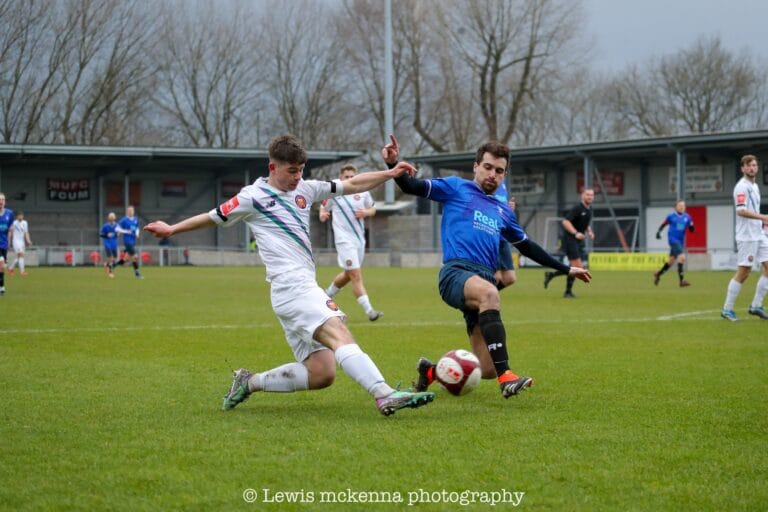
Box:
[0,267,768,511]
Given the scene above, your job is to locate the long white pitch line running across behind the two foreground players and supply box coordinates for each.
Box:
[0,309,721,334]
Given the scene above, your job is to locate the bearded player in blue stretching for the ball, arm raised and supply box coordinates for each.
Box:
[381,135,592,398]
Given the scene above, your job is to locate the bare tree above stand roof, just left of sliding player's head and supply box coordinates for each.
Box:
[155,1,262,147]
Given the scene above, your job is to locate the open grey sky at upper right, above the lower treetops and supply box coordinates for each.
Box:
[584,0,768,71]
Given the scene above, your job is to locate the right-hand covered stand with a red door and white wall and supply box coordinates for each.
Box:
[409,130,768,269]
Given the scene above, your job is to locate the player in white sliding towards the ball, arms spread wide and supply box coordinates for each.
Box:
[144,135,435,416]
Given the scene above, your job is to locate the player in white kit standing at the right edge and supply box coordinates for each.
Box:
[720,155,768,322]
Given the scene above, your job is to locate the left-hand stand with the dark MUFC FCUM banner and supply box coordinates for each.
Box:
[0,144,362,264]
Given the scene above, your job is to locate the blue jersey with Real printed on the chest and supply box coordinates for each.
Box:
[425,176,528,272]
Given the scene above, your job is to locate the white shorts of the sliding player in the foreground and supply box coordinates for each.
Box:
[270,276,346,362]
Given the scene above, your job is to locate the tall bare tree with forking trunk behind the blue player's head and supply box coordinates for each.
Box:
[438,0,581,146]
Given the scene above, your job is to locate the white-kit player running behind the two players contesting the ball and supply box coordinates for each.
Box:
[320,165,382,322]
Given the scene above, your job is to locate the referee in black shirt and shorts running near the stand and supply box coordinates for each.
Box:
[544,188,595,299]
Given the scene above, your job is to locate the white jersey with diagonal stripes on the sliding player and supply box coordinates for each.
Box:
[208,178,344,282]
